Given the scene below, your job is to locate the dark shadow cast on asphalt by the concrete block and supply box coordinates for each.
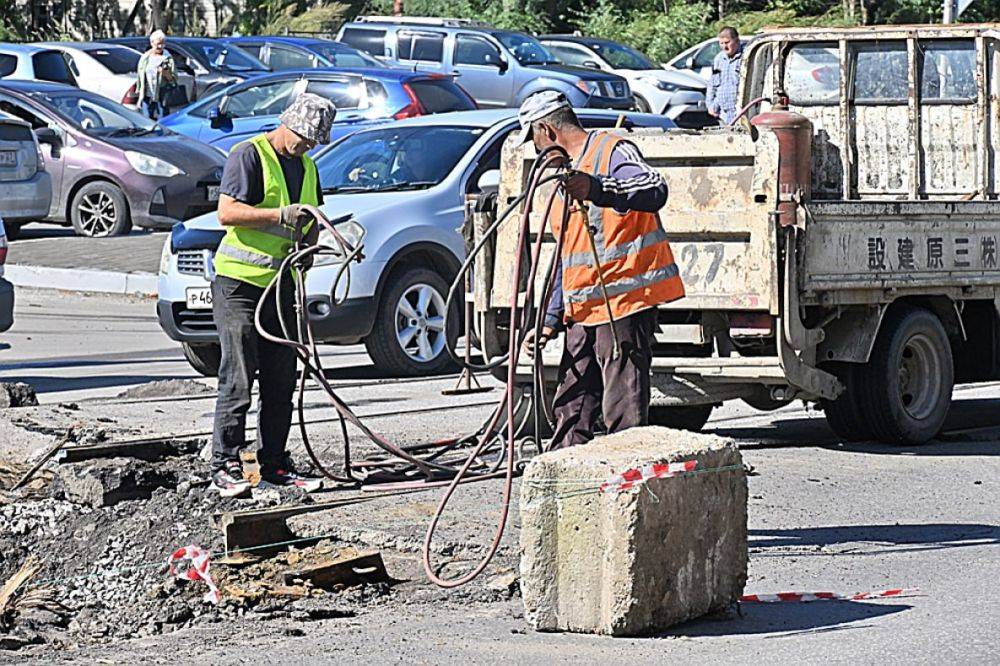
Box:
[662,601,912,637]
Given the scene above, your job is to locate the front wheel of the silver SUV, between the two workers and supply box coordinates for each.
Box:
[365,268,458,376]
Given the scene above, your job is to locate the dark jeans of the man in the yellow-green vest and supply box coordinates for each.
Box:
[212,275,296,470]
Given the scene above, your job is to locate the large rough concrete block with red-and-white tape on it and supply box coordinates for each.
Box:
[520,427,747,636]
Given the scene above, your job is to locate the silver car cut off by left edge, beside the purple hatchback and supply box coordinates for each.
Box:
[0,112,52,239]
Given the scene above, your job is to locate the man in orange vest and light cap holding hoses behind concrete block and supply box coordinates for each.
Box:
[518,92,684,448]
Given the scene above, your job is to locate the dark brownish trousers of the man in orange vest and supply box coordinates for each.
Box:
[552,308,656,448]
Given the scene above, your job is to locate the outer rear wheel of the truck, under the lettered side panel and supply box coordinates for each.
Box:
[857,307,955,444]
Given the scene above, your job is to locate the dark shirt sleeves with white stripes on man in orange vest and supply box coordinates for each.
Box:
[545,135,667,328]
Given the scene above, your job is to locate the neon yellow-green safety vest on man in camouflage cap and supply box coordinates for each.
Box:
[215,134,318,287]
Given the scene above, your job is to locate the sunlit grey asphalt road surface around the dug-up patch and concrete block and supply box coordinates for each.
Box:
[0,290,1000,664]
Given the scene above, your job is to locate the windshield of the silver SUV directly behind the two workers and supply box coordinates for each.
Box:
[316,125,483,194]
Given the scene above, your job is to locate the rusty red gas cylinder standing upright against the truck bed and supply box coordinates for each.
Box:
[750,104,812,227]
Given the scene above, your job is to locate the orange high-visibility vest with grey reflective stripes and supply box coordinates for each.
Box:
[551,132,684,325]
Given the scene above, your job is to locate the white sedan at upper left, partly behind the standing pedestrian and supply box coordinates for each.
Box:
[40,42,194,106]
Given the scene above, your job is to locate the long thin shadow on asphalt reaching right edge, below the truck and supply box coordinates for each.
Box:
[748,523,1000,557]
